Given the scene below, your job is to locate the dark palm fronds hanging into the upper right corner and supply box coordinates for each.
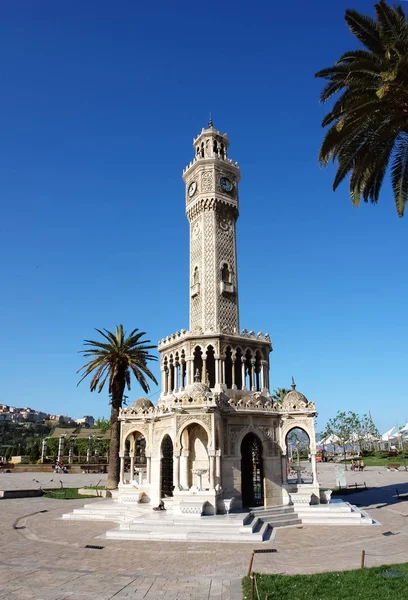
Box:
[316,0,408,217]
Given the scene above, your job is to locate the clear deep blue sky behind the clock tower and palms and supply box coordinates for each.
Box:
[0,0,408,430]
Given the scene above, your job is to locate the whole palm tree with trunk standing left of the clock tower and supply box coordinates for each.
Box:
[77,325,157,489]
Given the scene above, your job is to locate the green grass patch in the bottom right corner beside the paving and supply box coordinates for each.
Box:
[242,554,408,600]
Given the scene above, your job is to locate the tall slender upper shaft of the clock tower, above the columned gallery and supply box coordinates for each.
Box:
[183,120,241,335]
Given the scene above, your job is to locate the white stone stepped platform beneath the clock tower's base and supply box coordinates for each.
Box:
[62,499,374,543]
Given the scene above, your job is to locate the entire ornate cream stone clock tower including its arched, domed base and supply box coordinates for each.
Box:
[119,122,319,515]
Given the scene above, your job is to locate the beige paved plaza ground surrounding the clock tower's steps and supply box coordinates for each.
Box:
[0,464,408,600]
